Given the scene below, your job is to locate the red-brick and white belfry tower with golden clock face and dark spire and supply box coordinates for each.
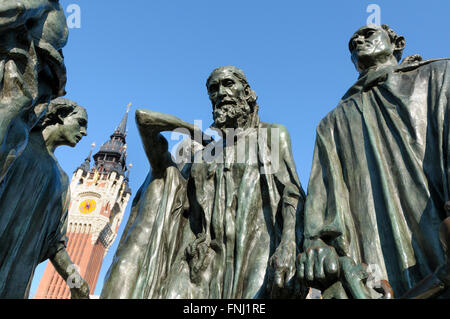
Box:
[34,105,131,299]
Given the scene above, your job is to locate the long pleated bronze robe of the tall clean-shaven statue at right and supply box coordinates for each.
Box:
[304,59,450,297]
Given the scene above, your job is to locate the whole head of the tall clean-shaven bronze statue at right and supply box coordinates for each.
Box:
[349,25,405,73]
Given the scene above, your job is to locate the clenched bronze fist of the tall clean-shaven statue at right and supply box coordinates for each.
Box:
[297,245,340,291]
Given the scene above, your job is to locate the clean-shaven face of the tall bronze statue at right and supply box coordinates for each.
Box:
[349,26,395,72]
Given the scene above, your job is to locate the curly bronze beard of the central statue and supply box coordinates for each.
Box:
[213,99,252,130]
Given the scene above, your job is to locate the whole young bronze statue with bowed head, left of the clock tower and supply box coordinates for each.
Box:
[0,98,89,299]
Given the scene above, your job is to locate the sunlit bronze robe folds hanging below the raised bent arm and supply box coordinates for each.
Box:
[101,166,190,299]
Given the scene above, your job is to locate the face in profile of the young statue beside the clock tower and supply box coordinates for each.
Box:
[59,108,87,147]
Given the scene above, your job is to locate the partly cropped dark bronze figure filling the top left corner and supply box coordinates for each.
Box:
[0,0,68,181]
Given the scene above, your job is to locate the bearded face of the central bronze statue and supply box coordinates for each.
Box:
[208,69,250,128]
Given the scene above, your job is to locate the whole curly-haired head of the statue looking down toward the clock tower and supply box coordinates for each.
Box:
[39,98,88,148]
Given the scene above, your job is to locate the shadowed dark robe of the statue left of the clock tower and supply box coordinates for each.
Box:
[0,132,70,299]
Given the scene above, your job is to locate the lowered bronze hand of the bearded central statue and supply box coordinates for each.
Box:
[269,242,295,298]
